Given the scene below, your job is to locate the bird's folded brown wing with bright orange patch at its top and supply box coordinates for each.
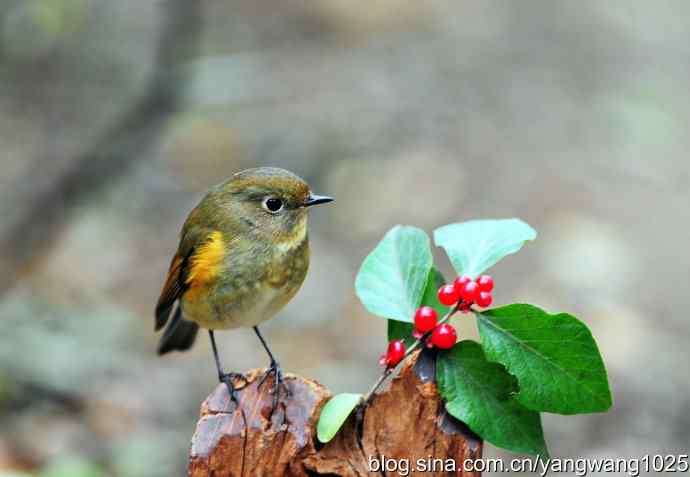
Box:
[155,229,225,331]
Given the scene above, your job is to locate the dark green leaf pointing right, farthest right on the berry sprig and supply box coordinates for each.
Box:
[477,304,612,414]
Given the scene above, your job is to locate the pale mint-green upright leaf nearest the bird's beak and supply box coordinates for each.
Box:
[355,225,432,322]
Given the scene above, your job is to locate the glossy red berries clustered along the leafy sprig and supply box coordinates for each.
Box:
[379,275,494,368]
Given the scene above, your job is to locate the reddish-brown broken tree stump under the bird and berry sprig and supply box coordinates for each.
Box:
[189,351,482,477]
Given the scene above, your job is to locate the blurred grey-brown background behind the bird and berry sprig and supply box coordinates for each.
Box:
[0,0,690,477]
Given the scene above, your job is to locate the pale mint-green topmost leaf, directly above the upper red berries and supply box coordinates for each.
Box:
[434,219,537,278]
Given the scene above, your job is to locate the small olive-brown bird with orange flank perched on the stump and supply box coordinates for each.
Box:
[155,167,333,409]
